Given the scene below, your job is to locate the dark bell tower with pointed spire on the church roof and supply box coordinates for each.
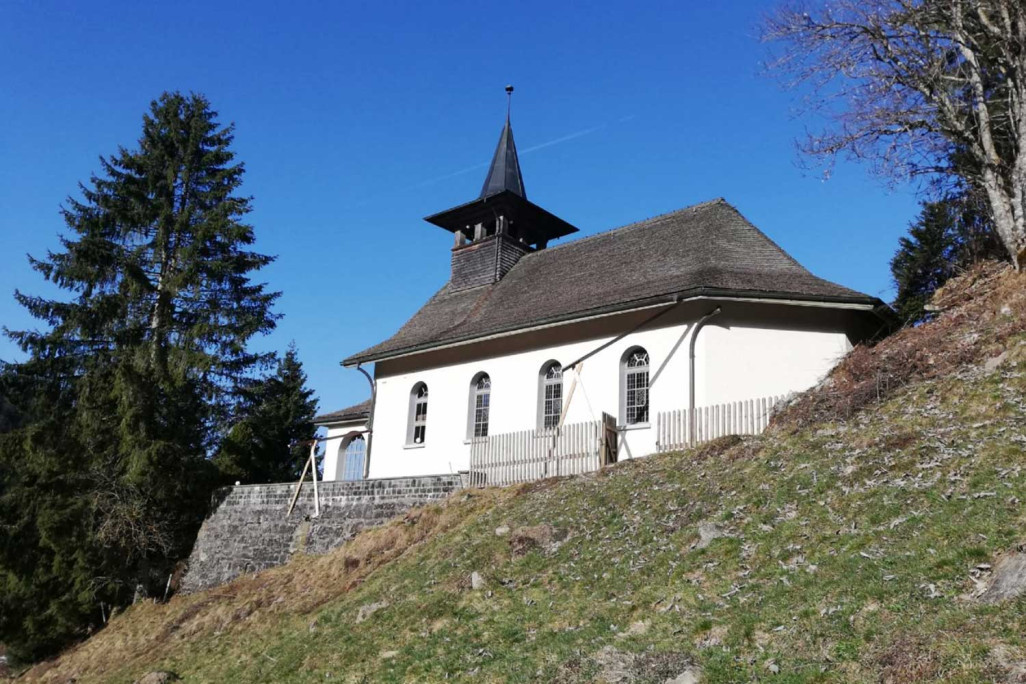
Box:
[425,85,578,290]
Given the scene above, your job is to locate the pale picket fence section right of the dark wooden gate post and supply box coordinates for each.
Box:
[656,396,786,451]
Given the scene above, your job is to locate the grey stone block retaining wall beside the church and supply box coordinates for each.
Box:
[181,475,463,593]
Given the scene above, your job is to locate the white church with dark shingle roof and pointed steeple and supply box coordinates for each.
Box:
[316,94,893,484]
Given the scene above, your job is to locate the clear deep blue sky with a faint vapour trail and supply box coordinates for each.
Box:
[0,0,916,410]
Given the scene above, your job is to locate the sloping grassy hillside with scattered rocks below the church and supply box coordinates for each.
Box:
[18,267,1026,682]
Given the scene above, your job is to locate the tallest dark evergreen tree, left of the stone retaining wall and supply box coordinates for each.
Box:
[0,92,277,657]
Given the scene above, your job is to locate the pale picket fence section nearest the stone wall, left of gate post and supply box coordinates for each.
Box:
[470,420,602,487]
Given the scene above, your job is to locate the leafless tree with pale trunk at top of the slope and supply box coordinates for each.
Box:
[764,0,1026,269]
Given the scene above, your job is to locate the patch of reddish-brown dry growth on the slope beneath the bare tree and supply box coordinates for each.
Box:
[773,261,1026,431]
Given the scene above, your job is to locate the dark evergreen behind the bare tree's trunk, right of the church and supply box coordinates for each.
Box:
[891,192,1001,324]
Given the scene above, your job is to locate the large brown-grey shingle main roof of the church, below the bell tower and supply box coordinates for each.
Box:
[344,199,882,365]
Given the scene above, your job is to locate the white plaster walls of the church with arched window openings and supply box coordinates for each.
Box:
[361,299,867,479]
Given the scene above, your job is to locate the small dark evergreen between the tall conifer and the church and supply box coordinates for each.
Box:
[215,345,317,483]
